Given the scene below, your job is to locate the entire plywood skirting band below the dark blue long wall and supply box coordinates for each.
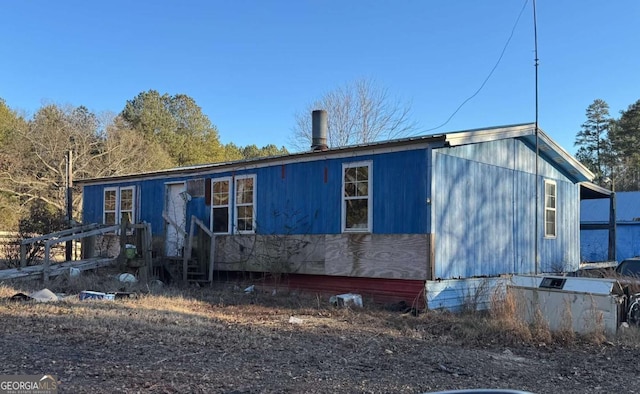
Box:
[214,234,431,280]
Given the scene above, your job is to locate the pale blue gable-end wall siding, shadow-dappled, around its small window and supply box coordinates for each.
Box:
[432,140,579,279]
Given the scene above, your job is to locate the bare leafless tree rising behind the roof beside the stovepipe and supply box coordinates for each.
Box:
[290,79,416,151]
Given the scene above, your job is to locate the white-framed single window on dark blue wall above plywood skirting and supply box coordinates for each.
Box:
[342,162,372,232]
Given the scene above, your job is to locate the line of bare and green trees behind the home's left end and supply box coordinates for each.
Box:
[0,90,288,231]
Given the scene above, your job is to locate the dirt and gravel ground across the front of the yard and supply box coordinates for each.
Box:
[0,274,640,394]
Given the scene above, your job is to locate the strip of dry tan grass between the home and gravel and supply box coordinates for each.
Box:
[0,270,640,346]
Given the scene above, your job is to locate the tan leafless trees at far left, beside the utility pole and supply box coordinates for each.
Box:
[0,104,172,228]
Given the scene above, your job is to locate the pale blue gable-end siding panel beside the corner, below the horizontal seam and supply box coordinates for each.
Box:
[433,154,514,278]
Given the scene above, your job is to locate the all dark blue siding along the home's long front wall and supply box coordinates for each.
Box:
[83,149,431,235]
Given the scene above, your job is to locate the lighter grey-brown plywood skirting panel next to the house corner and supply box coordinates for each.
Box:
[325,234,430,279]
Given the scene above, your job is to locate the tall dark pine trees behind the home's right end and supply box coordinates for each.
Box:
[575,99,640,191]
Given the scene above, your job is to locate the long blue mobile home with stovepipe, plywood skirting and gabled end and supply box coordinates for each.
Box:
[82,120,593,304]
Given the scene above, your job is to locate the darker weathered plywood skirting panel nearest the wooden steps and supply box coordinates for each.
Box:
[214,235,325,275]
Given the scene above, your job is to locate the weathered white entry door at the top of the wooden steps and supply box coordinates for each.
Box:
[164,182,187,256]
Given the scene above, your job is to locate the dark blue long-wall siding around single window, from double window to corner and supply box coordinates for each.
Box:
[247,150,429,234]
